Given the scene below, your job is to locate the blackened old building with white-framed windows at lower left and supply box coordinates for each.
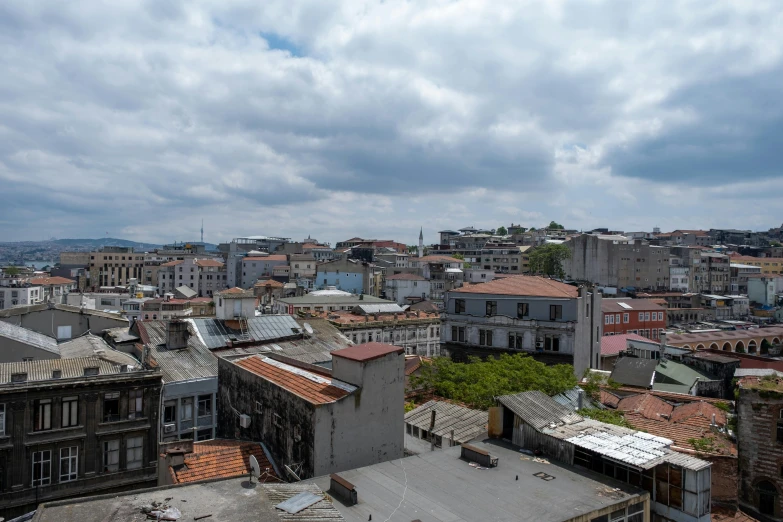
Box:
[0,357,161,518]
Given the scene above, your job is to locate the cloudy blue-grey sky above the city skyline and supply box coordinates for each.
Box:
[0,0,783,243]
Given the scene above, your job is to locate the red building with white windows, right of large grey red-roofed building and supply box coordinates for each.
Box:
[601,298,667,340]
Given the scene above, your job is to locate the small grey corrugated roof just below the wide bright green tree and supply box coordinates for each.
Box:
[405,401,489,444]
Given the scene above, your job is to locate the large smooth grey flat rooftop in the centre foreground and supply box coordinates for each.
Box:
[305,439,647,522]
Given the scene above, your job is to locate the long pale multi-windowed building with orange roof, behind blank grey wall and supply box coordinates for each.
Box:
[318,304,441,357]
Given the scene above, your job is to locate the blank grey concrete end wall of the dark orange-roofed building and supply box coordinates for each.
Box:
[315,353,405,476]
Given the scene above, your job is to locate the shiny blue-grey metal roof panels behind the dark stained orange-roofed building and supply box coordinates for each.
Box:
[186,315,303,349]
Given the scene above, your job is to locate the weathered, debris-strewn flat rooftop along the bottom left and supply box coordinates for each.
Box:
[33,477,343,522]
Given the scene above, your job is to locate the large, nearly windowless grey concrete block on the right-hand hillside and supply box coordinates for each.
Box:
[563,234,670,290]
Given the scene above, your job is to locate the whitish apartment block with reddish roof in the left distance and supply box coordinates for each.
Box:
[158,257,225,297]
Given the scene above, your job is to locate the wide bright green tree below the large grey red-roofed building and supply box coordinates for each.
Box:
[411,354,577,409]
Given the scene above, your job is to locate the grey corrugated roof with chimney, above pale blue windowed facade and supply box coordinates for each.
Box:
[138,321,217,383]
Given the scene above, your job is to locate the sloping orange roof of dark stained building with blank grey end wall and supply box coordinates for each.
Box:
[235,354,352,405]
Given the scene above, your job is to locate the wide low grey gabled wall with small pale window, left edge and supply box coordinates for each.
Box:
[0,308,128,338]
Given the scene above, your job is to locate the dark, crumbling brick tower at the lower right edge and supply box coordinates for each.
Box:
[737,371,783,520]
